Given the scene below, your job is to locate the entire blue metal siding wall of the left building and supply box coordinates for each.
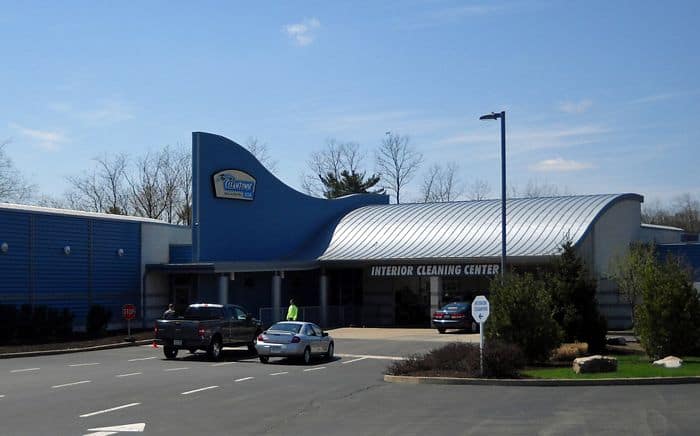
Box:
[0,210,141,326]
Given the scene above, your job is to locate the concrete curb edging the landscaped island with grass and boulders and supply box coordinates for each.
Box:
[384,375,700,386]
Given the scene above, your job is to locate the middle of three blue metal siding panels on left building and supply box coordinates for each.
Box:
[34,215,90,320]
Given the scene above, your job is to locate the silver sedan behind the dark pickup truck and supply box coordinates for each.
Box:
[255,321,335,364]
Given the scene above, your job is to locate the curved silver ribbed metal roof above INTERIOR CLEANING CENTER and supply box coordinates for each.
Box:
[319,194,643,261]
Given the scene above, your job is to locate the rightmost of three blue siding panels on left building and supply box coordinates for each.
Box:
[91,220,141,310]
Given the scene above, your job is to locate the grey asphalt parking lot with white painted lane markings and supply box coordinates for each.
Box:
[0,329,700,435]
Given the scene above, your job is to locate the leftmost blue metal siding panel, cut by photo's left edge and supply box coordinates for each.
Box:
[0,211,30,304]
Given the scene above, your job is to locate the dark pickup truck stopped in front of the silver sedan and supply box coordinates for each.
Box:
[155,304,262,360]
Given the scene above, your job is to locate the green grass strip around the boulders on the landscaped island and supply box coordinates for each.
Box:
[522,354,700,380]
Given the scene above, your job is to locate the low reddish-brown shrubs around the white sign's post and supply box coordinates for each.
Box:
[386,341,525,377]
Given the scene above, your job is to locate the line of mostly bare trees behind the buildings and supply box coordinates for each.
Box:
[0,132,700,232]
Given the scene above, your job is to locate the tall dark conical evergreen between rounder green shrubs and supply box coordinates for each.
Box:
[545,240,607,353]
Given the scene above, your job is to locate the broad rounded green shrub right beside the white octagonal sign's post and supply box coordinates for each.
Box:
[486,274,562,361]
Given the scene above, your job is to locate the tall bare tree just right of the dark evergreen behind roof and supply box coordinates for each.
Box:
[376,132,423,204]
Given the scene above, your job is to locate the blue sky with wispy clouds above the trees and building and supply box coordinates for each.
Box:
[0,0,700,204]
